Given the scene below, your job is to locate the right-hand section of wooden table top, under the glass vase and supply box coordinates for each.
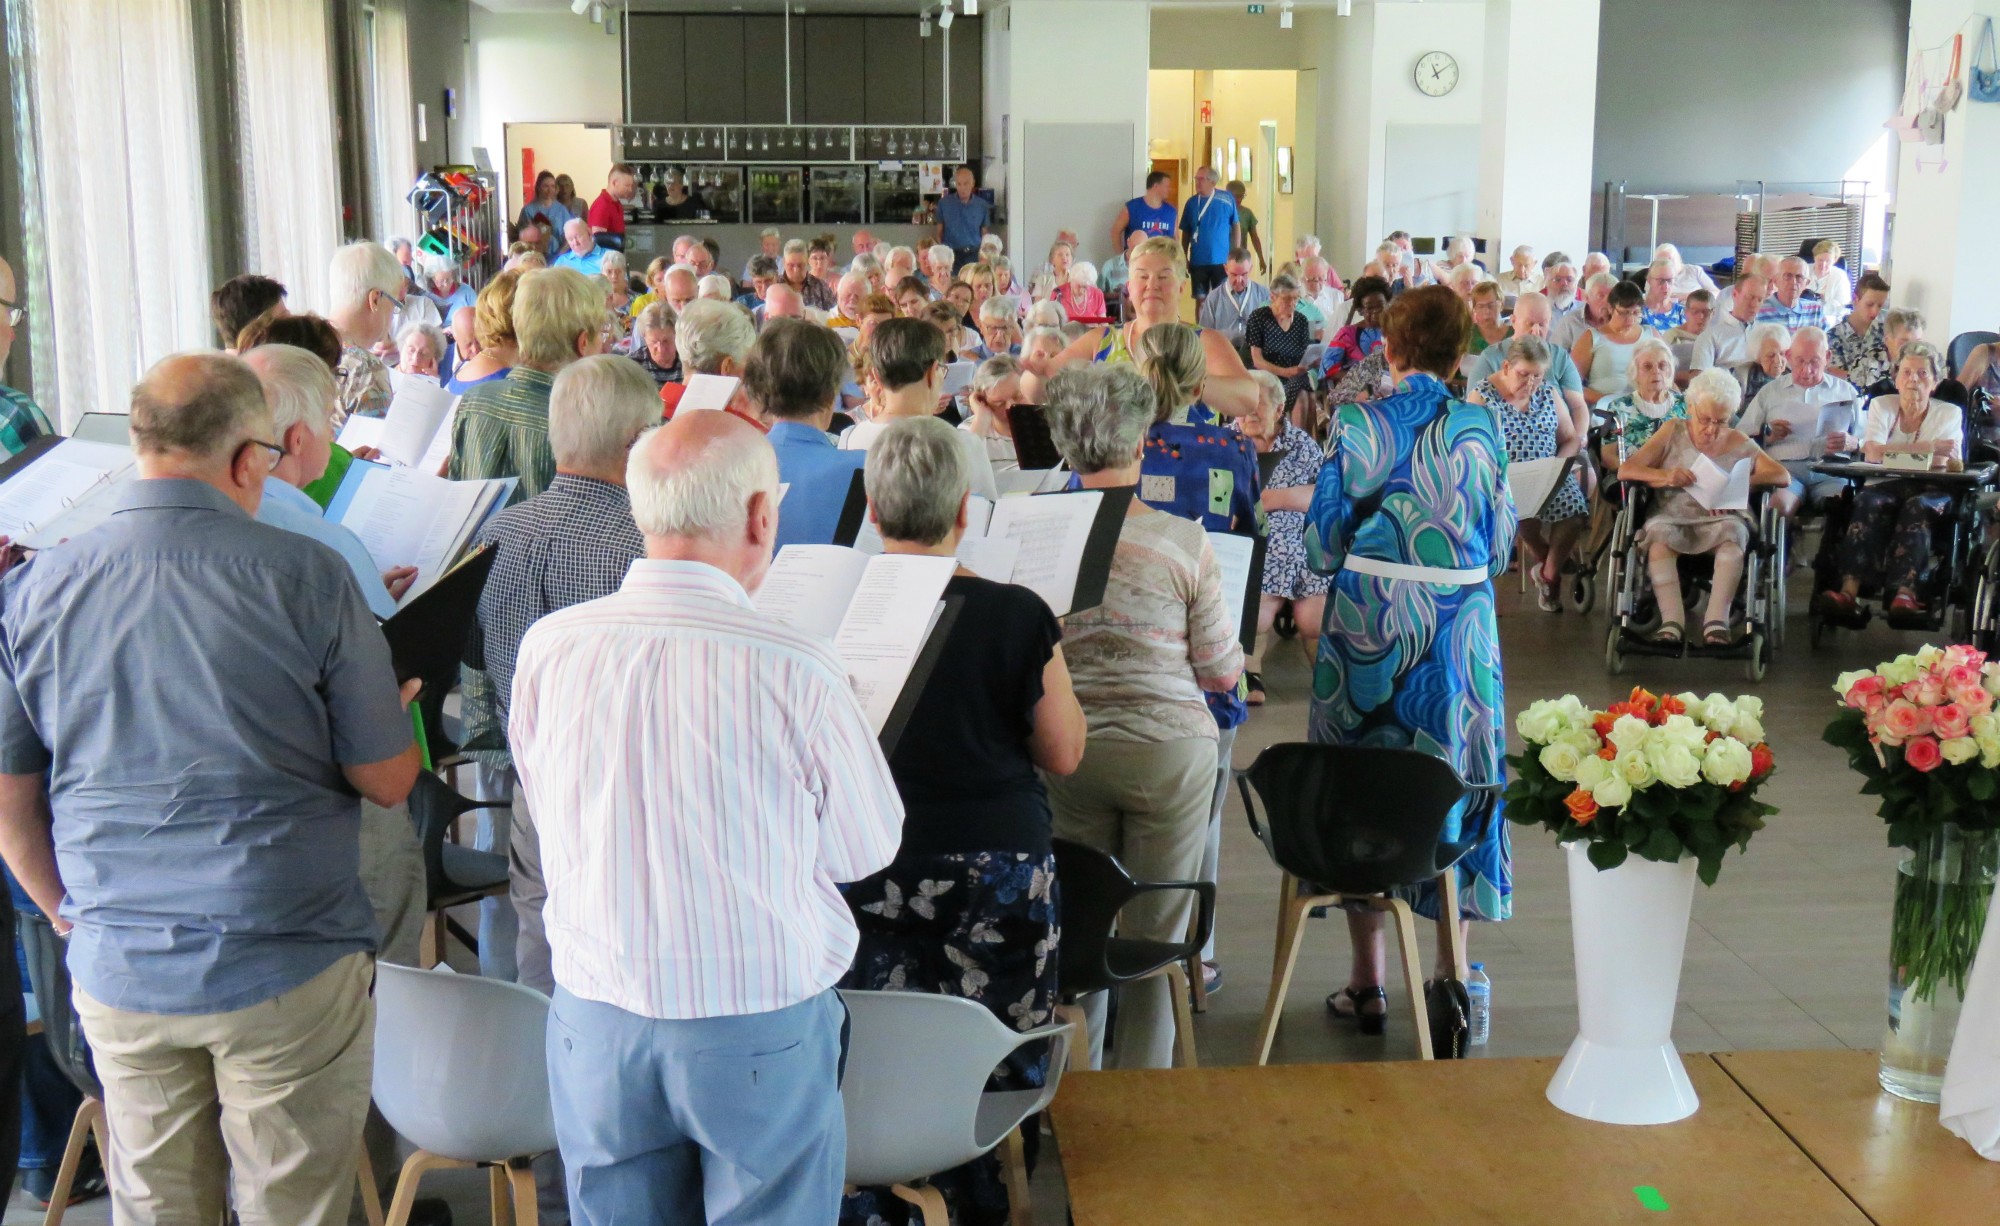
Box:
[1716,1050,2000,1226]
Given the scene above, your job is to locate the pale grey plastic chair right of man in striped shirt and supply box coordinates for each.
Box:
[840,992,1076,1226]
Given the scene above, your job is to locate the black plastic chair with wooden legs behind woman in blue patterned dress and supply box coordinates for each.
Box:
[1232,742,1500,1064]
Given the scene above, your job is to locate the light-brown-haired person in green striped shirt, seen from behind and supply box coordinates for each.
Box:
[446,268,604,502]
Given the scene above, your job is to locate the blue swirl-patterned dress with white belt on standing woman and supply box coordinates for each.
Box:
[1306,374,1514,920]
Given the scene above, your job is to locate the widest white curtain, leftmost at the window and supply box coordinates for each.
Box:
[10,0,212,428]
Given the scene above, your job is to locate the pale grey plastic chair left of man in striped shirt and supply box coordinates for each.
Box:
[374,962,556,1226]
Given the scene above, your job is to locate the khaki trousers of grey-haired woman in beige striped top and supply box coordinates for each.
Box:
[1042,736,1216,1068]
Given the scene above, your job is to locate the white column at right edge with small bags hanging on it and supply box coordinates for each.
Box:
[1890,0,2000,338]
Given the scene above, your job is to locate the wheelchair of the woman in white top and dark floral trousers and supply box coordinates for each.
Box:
[1810,448,2000,648]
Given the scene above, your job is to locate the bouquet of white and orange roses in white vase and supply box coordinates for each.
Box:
[1506,690,1778,886]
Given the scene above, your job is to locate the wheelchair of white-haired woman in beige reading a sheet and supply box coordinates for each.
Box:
[1604,482,1786,682]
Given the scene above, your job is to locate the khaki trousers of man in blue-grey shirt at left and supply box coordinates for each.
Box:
[76,954,374,1226]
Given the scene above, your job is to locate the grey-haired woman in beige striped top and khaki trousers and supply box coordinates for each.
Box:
[1046,362,1244,1068]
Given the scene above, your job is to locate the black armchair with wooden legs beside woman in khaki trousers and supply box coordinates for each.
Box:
[1052,838,1216,1070]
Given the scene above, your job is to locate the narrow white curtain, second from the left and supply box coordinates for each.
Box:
[236,0,340,320]
